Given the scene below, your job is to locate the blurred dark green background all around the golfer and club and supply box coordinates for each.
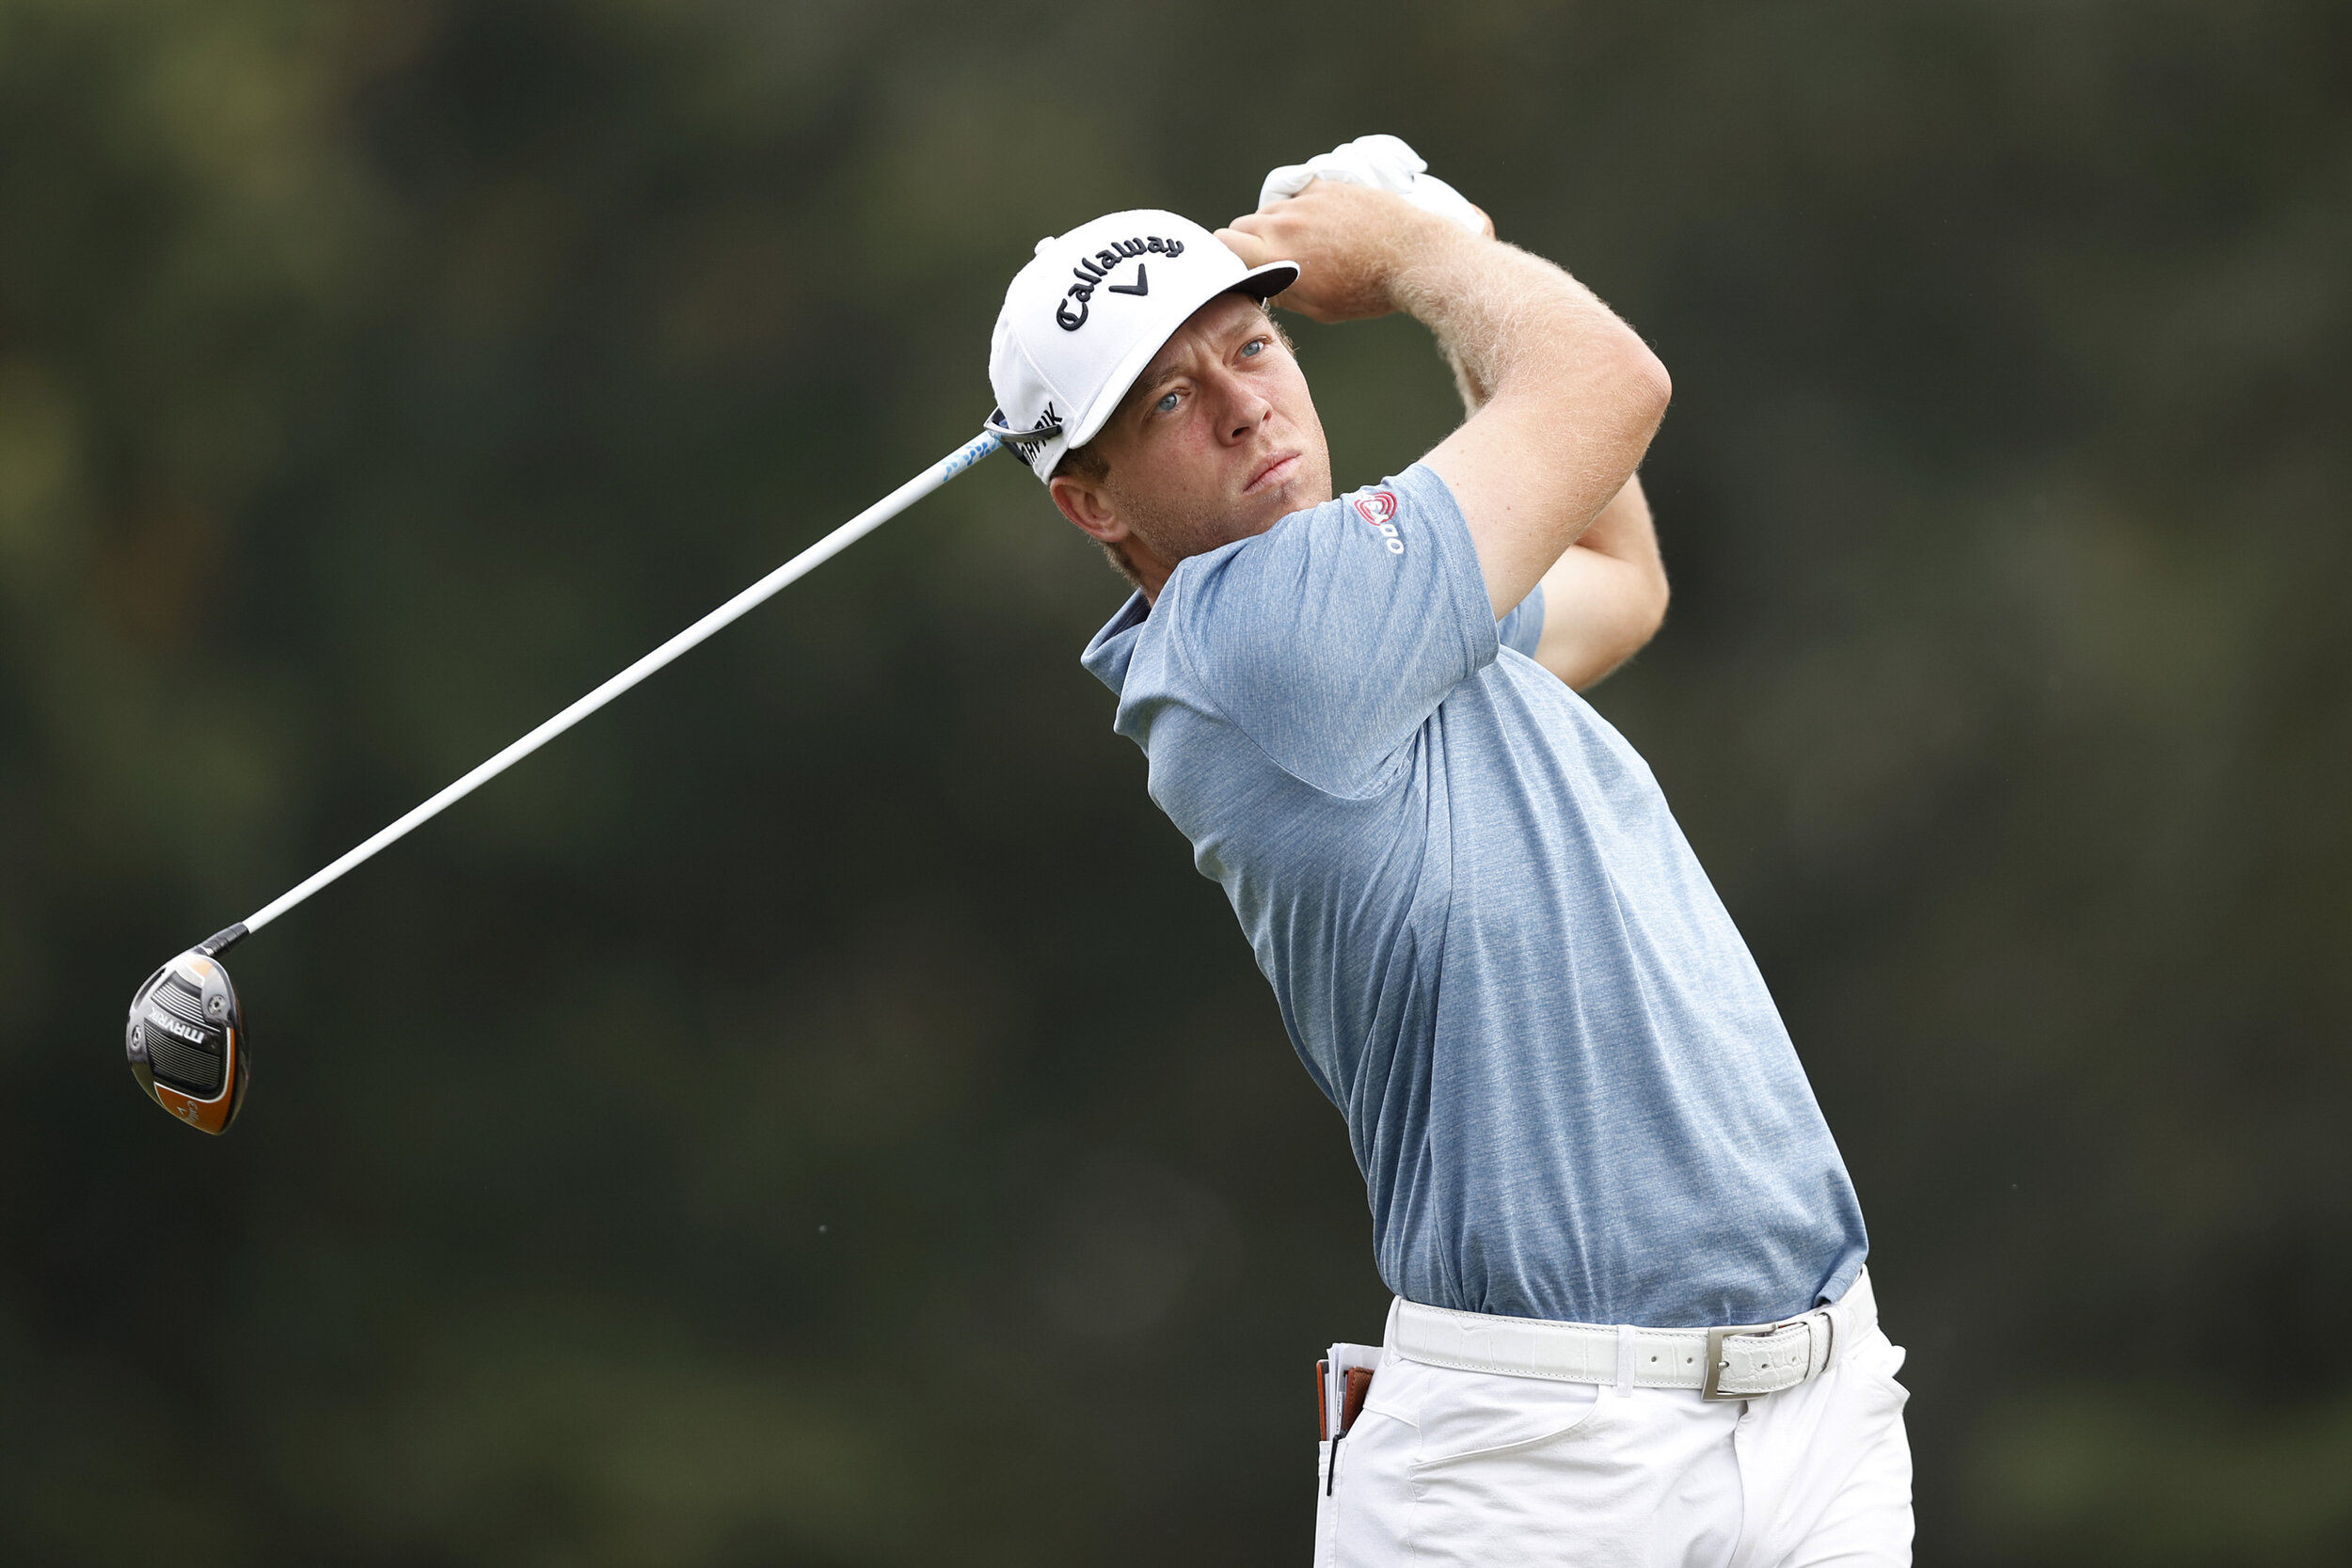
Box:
[0,0,2352,1568]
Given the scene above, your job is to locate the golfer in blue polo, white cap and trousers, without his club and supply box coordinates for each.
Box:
[991,143,1913,1568]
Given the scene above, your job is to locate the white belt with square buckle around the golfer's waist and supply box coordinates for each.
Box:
[1388,1270,1880,1399]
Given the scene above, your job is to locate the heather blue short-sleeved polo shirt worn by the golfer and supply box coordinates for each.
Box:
[1085,466,1866,1328]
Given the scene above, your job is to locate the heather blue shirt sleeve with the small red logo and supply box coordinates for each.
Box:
[1160,466,1501,795]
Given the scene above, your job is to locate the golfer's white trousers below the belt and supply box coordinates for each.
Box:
[1315,1286,1913,1568]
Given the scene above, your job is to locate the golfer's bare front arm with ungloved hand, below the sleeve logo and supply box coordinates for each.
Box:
[1218,181,1673,620]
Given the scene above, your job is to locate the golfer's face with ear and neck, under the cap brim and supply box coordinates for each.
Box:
[1054,293,1331,594]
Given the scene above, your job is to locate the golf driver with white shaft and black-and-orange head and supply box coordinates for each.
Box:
[122,416,1040,1133]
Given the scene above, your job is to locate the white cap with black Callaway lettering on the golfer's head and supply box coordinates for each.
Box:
[988,207,1298,480]
